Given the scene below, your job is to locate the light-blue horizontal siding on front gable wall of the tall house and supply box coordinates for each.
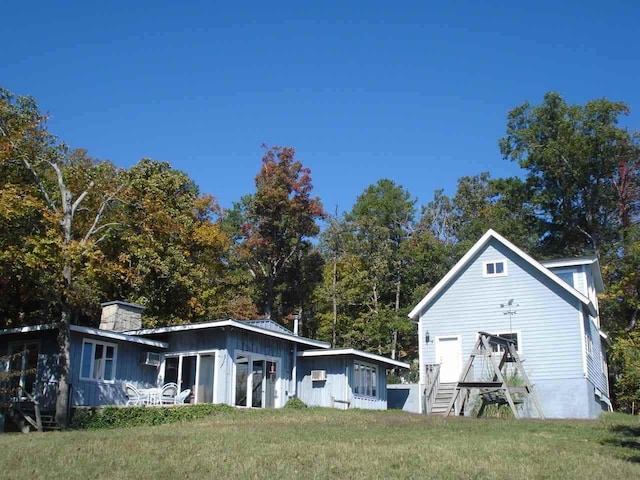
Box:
[419,240,588,417]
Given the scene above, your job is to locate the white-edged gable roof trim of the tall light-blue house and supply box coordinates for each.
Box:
[409,229,597,320]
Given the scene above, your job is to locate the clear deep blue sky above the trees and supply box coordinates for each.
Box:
[5,0,640,211]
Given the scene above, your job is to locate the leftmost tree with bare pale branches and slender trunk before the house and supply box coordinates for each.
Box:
[0,89,120,426]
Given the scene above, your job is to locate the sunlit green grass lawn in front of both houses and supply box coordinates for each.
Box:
[0,409,640,480]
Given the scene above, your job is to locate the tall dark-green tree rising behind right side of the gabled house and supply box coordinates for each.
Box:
[500,93,638,254]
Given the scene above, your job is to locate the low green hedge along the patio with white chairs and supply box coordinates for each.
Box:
[71,404,235,429]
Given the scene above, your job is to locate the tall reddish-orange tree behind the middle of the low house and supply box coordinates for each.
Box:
[230,146,324,318]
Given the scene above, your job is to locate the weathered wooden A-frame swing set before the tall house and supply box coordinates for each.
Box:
[447,332,544,419]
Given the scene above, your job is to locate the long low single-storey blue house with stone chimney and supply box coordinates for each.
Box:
[0,301,409,432]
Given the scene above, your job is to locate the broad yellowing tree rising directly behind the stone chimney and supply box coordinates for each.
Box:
[90,159,230,326]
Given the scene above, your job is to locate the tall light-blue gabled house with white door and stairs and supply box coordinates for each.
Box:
[409,230,611,418]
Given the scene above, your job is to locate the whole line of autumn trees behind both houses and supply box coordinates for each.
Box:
[0,89,640,420]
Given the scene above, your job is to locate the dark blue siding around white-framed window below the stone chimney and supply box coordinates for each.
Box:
[71,332,158,406]
